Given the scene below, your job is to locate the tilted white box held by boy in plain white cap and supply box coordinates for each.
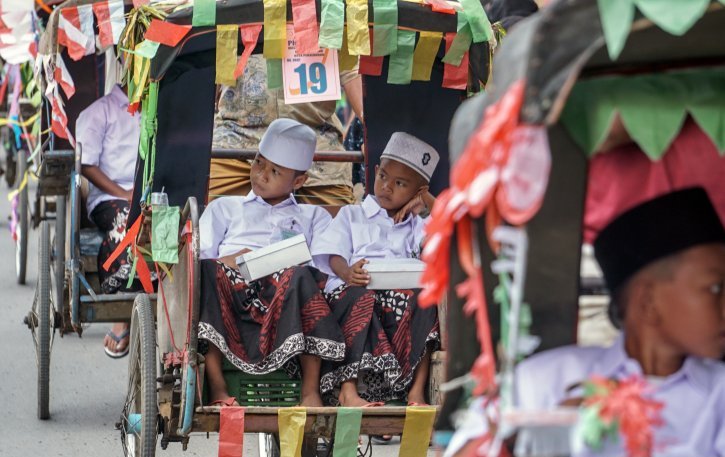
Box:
[236,234,312,282]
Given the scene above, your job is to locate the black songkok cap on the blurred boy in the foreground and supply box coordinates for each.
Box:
[594,187,725,293]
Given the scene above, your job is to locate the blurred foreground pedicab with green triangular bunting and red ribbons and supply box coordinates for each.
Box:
[421,0,725,456]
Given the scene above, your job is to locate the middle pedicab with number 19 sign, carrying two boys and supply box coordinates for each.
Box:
[118,0,498,456]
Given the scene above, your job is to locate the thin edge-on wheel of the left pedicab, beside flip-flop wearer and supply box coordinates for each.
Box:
[32,221,55,420]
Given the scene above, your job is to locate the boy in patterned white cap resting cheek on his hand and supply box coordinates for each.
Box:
[312,132,439,406]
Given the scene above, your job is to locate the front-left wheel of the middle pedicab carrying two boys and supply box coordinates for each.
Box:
[120,294,159,457]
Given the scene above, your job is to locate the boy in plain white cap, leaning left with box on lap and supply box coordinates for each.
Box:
[199,119,345,406]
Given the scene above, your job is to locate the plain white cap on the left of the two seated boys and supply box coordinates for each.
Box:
[259,119,317,171]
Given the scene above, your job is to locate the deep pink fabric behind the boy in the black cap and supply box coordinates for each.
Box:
[584,119,725,243]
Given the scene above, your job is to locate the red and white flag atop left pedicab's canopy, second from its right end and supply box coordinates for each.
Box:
[58,5,96,60]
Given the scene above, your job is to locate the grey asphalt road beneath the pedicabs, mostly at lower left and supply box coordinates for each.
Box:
[0,183,424,457]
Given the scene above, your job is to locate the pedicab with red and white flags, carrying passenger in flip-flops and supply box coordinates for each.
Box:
[25,0,153,419]
